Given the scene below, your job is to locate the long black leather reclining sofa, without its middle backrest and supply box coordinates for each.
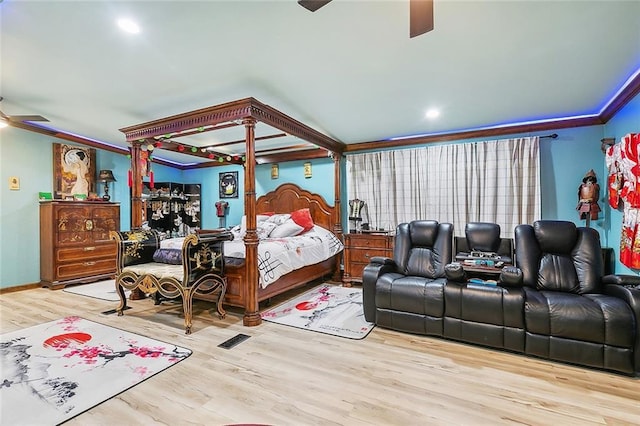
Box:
[363,221,640,376]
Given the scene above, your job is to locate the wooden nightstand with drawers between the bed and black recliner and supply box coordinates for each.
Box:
[342,233,393,284]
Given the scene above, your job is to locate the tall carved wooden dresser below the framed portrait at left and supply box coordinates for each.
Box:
[40,200,120,289]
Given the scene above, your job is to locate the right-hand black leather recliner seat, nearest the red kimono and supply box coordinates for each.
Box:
[512,221,640,374]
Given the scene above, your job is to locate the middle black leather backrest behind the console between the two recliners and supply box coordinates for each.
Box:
[453,222,513,264]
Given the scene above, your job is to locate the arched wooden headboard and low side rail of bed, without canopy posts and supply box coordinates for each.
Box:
[195,183,342,322]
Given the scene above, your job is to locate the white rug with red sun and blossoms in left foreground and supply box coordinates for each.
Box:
[0,317,191,425]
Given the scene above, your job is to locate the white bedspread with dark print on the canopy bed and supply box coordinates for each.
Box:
[224,225,344,288]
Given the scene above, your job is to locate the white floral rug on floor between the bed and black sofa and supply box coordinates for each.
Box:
[261,284,374,339]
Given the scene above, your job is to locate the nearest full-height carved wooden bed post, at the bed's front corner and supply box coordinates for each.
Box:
[242,118,262,327]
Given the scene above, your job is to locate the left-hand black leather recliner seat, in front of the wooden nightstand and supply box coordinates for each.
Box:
[362,220,453,335]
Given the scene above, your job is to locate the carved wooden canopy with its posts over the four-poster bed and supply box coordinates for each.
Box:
[120,98,345,325]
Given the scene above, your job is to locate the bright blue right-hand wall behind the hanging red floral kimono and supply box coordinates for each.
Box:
[601,95,640,274]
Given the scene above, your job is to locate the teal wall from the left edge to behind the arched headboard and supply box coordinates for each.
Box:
[0,127,335,288]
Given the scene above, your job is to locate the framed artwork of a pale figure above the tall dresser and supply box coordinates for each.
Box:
[53,143,96,199]
